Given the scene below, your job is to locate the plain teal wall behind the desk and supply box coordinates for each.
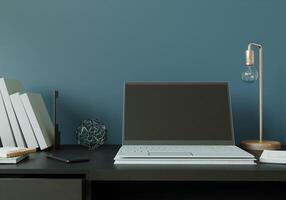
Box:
[0,0,286,144]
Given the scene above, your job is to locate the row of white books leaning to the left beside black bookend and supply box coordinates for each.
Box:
[0,78,54,150]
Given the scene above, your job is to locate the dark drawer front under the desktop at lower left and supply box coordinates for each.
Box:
[0,178,83,200]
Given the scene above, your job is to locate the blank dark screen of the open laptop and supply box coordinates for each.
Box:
[123,83,233,144]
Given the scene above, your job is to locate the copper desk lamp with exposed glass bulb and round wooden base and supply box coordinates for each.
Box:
[241,43,281,150]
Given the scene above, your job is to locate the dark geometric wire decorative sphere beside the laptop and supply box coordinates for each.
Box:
[76,119,107,150]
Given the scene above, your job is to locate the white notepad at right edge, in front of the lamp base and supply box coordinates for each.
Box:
[259,150,286,164]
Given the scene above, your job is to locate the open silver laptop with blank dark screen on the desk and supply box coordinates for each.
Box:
[114,82,255,164]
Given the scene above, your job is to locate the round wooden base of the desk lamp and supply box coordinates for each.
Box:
[240,140,281,150]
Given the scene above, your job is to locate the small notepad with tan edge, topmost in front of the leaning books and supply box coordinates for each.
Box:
[0,147,36,158]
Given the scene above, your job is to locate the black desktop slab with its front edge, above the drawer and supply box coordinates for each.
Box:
[0,145,286,181]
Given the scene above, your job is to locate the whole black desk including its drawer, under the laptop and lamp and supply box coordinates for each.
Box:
[0,146,286,200]
